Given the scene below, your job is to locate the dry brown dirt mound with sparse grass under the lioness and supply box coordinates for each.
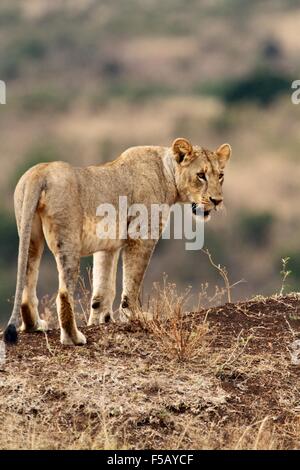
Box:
[0,295,300,449]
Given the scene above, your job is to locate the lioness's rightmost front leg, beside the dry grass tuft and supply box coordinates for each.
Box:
[119,240,156,321]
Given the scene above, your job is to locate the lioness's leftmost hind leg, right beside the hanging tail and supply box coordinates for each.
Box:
[21,214,47,331]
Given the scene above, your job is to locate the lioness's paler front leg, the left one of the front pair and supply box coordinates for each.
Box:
[88,250,120,325]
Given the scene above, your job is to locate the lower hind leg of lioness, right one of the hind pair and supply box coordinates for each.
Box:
[55,252,86,345]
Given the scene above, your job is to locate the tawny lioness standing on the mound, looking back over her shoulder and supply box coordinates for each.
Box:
[4,138,231,345]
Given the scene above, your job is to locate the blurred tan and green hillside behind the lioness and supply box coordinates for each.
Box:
[0,0,300,323]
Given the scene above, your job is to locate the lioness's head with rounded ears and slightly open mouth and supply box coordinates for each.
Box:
[172,138,231,220]
